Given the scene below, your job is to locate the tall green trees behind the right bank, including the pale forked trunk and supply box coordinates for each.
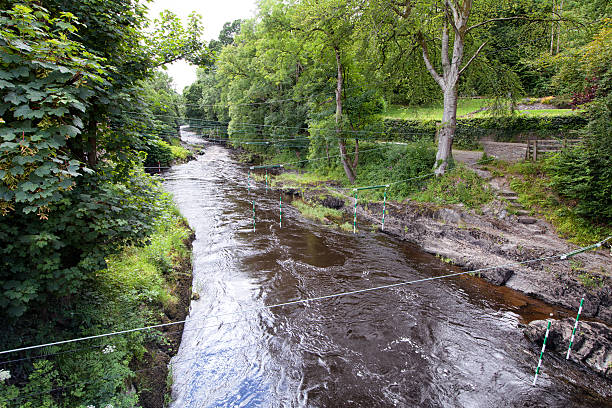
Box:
[189,0,610,181]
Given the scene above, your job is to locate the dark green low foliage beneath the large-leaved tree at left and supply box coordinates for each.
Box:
[0,172,161,317]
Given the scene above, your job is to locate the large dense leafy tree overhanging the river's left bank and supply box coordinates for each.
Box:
[0,0,205,317]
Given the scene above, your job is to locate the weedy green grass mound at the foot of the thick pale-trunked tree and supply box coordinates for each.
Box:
[412,165,495,209]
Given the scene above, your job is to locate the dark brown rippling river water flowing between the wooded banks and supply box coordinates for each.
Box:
[164,130,609,408]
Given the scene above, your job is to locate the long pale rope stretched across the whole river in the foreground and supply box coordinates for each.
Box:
[0,236,612,354]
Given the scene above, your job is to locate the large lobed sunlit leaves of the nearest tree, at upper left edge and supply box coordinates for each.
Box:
[0,1,104,218]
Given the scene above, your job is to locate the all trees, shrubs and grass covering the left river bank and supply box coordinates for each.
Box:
[0,0,209,407]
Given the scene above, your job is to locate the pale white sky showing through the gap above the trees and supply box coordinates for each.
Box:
[149,0,257,92]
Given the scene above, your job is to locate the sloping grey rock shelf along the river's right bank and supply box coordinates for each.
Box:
[276,167,612,378]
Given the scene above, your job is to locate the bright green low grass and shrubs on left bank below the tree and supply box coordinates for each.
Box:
[0,194,190,408]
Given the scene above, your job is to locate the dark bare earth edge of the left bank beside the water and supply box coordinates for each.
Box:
[130,225,195,408]
